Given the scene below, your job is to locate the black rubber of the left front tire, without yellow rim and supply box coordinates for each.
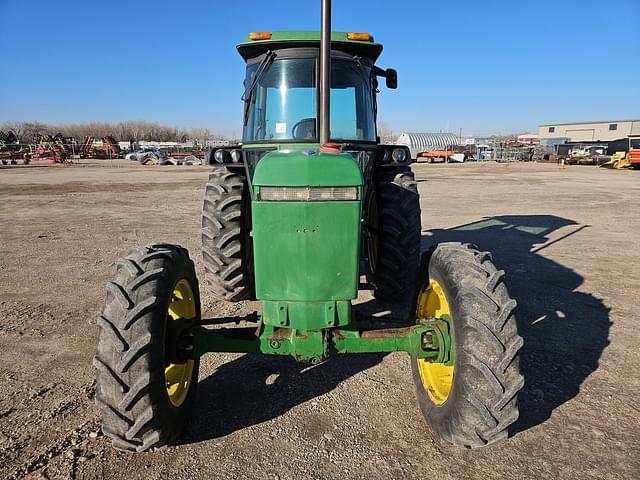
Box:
[93,244,199,452]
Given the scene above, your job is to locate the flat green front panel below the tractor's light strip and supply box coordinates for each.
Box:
[252,201,360,301]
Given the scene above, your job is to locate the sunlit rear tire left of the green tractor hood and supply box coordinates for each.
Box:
[202,166,254,302]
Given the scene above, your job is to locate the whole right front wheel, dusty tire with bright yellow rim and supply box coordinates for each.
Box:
[411,243,524,448]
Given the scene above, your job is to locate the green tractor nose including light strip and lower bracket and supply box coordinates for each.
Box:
[251,152,363,329]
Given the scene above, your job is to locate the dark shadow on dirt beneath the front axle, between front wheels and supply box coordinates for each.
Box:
[182,353,384,444]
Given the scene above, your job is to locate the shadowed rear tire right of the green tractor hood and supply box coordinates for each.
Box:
[367,166,422,301]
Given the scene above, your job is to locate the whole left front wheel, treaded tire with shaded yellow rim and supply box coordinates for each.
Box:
[94,244,200,452]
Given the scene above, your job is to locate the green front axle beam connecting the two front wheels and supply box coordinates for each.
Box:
[191,315,453,365]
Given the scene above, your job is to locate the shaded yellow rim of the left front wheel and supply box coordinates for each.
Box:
[164,279,196,407]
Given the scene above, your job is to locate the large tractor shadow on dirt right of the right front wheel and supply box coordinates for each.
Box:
[422,215,611,435]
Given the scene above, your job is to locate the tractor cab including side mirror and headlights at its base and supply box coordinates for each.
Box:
[209,31,410,177]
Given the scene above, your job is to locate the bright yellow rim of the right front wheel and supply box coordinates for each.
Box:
[416,279,454,405]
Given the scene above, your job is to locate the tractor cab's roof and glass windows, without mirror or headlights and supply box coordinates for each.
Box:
[238,32,382,144]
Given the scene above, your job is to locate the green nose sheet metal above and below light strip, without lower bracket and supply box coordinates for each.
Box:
[251,152,363,302]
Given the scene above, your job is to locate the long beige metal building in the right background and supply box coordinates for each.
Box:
[538,120,640,142]
